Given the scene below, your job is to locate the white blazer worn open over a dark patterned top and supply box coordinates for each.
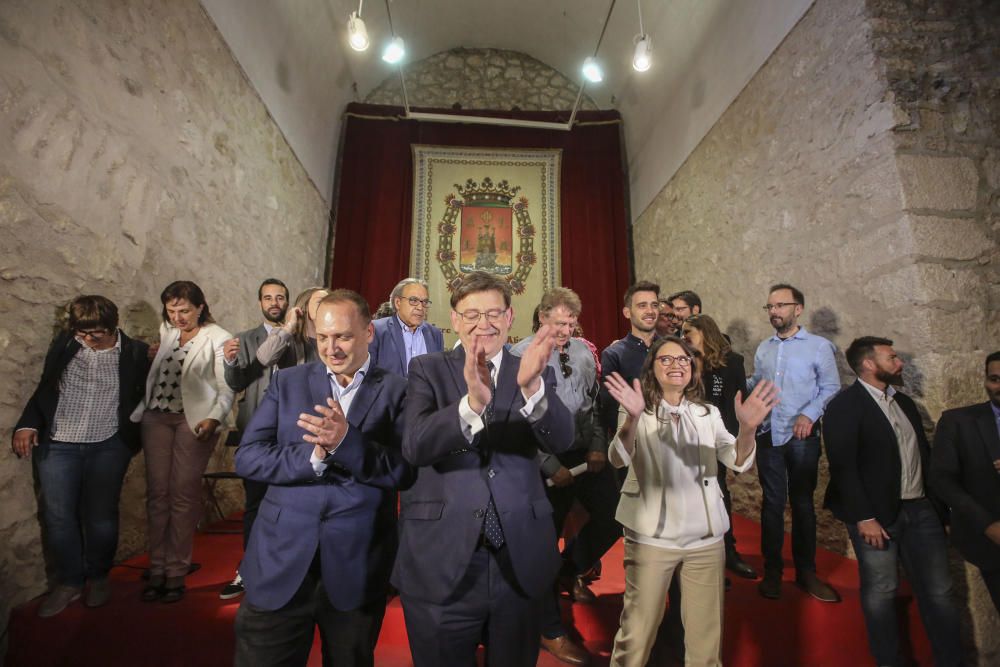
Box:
[132,322,234,431]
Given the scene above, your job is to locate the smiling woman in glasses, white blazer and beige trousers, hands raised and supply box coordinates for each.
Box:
[606,337,777,667]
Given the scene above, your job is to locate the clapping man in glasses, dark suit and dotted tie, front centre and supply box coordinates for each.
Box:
[392,272,573,667]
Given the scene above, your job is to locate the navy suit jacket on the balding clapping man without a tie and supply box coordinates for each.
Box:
[236,362,412,610]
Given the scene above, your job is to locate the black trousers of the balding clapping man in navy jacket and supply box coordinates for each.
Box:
[235,561,386,667]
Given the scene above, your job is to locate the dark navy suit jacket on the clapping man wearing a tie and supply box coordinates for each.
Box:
[392,347,573,603]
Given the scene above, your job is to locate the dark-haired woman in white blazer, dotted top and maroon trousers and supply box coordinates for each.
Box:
[132,280,233,602]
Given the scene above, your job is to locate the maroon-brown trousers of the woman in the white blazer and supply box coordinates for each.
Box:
[142,410,216,577]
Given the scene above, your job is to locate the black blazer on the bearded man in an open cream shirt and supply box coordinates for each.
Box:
[823,382,946,527]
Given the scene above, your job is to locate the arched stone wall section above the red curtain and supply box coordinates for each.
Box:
[365,48,597,111]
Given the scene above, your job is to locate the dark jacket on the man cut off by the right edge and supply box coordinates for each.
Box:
[931,402,1000,572]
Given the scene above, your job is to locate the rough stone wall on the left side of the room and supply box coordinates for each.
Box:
[0,0,328,624]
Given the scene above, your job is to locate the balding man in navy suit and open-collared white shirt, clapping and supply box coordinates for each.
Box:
[236,290,412,667]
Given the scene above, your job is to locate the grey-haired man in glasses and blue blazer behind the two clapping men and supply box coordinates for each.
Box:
[368,278,444,377]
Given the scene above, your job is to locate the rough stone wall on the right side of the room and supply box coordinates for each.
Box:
[633,0,1000,664]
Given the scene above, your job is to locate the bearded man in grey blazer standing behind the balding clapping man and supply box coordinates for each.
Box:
[219,278,299,600]
